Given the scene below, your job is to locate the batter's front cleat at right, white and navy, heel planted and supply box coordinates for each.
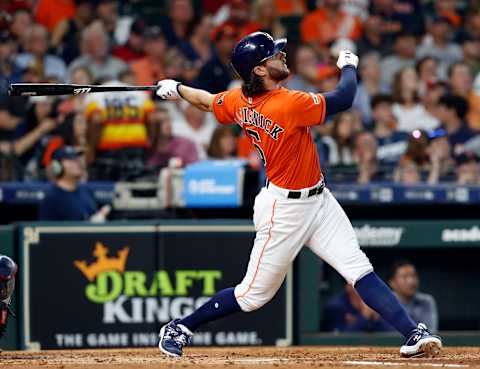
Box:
[400,323,442,357]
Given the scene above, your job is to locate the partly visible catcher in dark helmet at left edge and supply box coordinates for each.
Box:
[0,255,18,338]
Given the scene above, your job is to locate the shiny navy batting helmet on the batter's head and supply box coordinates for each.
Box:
[232,32,287,81]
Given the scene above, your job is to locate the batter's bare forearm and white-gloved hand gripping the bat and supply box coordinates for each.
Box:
[157,79,215,112]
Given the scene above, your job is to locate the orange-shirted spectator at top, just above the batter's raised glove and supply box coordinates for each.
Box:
[300,0,362,51]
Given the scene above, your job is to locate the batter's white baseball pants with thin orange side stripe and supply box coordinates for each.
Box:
[235,183,373,312]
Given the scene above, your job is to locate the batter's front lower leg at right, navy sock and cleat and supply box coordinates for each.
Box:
[355,272,442,357]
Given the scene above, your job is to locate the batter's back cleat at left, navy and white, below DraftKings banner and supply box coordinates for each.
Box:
[158,319,193,357]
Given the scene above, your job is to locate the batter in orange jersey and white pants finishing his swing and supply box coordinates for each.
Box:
[157,32,442,357]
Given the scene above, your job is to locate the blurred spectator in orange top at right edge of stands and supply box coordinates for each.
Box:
[448,62,480,130]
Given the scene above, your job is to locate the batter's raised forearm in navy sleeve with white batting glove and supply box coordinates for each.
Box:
[323,50,358,116]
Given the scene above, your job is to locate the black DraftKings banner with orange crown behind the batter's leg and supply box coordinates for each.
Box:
[21,226,286,349]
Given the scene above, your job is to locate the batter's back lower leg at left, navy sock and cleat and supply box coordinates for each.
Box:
[158,288,241,356]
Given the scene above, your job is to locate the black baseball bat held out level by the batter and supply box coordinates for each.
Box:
[8,83,158,96]
